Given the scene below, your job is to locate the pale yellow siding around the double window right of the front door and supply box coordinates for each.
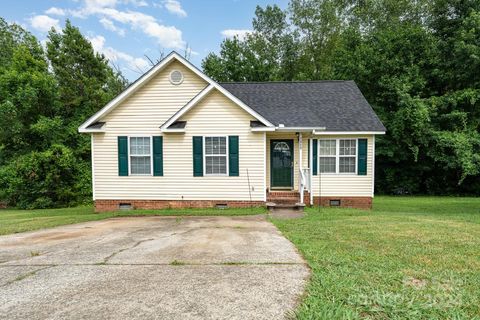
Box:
[312,135,373,197]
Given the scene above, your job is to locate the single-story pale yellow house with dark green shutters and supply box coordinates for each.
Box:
[79,52,385,211]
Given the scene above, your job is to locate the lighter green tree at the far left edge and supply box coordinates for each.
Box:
[0,40,58,165]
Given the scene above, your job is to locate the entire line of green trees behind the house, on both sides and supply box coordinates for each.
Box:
[0,0,480,208]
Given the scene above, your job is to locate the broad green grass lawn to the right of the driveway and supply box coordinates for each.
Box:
[272,197,480,319]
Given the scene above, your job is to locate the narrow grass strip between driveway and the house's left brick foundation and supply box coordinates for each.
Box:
[0,206,266,235]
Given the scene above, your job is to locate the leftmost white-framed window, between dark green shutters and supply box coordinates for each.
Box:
[130,137,152,175]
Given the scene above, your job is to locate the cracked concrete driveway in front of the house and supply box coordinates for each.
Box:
[0,216,309,319]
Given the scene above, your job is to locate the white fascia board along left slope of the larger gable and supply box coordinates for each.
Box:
[78,52,178,132]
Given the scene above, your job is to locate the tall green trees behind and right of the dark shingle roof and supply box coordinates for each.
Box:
[202,0,480,195]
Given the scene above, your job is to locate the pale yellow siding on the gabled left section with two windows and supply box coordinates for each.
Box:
[94,75,265,201]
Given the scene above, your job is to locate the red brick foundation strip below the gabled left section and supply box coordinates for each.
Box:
[95,200,265,212]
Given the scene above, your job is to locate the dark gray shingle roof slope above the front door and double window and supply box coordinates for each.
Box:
[220,81,385,131]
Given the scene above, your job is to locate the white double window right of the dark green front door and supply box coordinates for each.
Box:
[319,139,357,173]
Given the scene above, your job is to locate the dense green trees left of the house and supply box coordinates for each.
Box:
[0,18,126,208]
